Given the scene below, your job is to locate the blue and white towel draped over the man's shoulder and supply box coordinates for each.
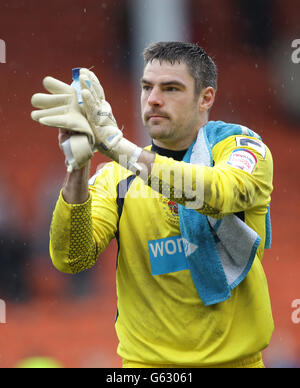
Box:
[179,121,271,306]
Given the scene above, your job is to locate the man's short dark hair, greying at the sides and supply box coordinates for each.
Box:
[144,42,218,96]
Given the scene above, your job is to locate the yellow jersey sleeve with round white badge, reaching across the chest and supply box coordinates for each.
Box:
[148,136,273,218]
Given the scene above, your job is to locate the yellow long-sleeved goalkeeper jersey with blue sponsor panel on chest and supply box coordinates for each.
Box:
[50,136,273,367]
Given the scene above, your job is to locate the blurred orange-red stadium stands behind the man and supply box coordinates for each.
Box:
[0,0,300,368]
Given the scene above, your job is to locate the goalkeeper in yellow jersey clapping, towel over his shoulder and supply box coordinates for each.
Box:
[32,42,273,368]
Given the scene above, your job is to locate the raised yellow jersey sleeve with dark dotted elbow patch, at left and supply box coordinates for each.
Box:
[50,162,118,274]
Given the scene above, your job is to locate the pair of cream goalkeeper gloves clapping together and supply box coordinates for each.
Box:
[31,69,142,173]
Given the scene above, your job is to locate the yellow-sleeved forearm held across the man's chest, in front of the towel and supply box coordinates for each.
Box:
[144,151,255,218]
